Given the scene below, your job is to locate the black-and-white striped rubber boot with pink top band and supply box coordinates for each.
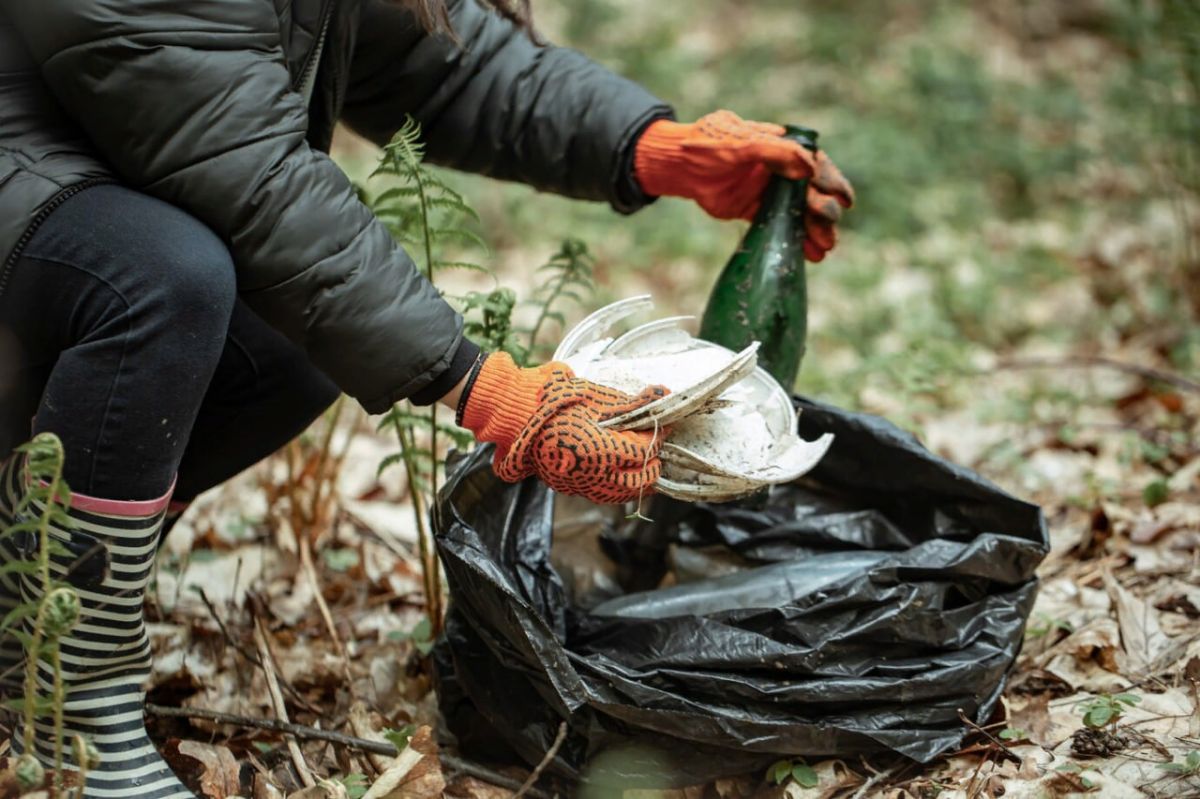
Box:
[12,460,193,799]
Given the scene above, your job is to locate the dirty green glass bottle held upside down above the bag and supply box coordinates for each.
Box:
[700,125,817,392]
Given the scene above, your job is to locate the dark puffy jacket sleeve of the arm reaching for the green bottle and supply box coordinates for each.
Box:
[343,0,672,212]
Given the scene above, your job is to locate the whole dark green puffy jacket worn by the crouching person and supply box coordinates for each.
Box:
[0,0,670,411]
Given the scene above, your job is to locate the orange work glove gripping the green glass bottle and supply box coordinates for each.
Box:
[634,110,854,262]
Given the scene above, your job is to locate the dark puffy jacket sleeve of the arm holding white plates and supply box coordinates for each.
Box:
[12,0,472,413]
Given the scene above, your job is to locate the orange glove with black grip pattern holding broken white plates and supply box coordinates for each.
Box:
[460,353,667,505]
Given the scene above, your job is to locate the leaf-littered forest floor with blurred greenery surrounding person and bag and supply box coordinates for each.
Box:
[2,0,1200,799]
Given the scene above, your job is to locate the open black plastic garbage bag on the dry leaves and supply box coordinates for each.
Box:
[434,398,1048,785]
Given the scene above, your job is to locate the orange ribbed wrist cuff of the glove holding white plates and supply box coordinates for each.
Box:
[462,353,572,458]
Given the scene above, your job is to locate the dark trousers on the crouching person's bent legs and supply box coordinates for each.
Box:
[0,185,338,500]
